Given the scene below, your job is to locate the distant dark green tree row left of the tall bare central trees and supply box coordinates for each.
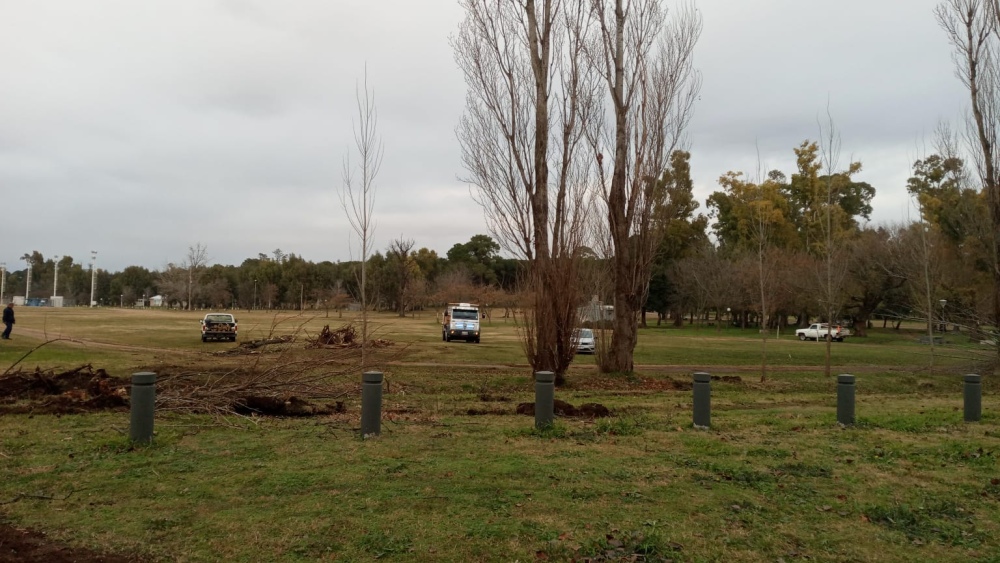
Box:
[5,235,518,314]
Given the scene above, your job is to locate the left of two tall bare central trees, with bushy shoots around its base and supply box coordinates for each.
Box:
[453,0,595,384]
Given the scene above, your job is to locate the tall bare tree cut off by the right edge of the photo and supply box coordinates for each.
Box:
[934,0,1000,355]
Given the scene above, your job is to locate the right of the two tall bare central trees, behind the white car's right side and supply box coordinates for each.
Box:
[586,0,702,372]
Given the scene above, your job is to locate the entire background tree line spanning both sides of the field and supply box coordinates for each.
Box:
[6,142,994,344]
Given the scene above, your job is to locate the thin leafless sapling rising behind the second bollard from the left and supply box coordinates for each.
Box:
[340,71,383,370]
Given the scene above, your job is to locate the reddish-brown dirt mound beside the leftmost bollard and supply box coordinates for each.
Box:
[0,364,131,414]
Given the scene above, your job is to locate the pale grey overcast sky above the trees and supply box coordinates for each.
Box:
[0,0,967,271]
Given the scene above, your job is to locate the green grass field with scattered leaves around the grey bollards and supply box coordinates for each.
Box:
[0,308,1000,562]
